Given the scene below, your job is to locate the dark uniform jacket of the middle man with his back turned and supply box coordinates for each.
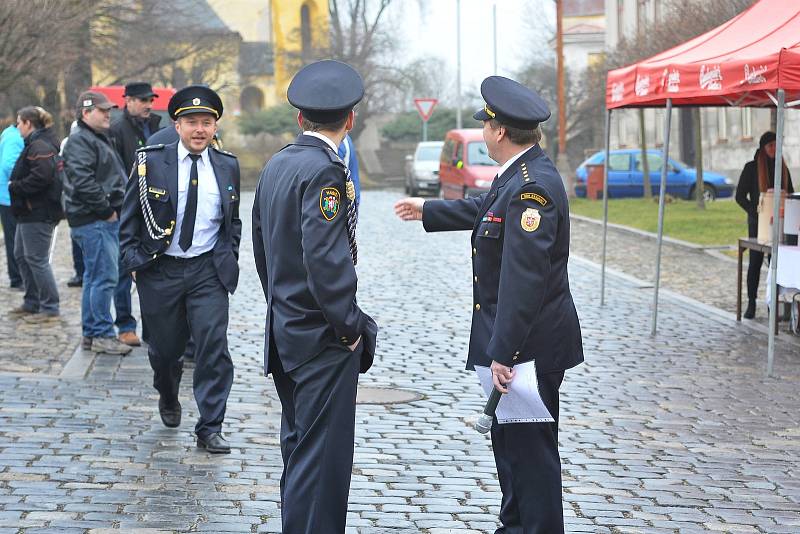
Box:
[253,135,378,373]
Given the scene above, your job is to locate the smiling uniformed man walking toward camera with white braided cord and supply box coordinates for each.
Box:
[120,85,242,453]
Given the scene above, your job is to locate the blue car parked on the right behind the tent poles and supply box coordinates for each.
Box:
[575,148,734,201]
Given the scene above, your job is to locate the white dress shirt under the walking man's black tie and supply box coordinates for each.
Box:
[166,142,222,258]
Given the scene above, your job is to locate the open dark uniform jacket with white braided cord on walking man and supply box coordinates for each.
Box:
[119,141,242,293]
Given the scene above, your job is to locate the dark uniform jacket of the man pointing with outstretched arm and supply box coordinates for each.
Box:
[422,145,583,373]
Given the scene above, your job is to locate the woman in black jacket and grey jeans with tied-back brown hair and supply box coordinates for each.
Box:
[8,106,64,322]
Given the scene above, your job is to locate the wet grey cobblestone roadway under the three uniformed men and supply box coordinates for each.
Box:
[0,192,800,534]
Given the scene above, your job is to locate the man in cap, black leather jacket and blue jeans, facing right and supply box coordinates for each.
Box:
[64,91,131,354]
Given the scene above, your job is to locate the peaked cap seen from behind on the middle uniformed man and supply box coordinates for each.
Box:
[286,59,364,124]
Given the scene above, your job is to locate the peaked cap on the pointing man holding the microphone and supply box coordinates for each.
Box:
[473,76,550,130]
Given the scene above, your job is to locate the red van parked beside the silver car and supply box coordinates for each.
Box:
[439,128,500,198]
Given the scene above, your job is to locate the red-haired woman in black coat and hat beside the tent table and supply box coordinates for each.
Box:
[736,132,794,319]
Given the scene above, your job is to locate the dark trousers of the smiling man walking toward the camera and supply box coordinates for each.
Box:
[136,253,233,438]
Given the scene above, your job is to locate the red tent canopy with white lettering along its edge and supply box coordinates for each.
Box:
[606,0,800,109]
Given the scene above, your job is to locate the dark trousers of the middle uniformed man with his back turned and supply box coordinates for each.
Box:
[269,341,364,534]
